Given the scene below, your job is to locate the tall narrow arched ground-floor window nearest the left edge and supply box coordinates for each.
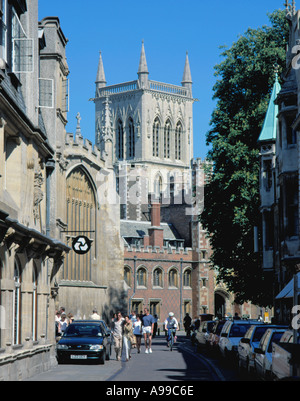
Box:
[13,257,22,344]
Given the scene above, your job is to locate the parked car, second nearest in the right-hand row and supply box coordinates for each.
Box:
[254,328,285,380]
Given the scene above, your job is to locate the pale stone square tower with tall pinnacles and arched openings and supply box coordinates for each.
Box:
[93,43,194,220]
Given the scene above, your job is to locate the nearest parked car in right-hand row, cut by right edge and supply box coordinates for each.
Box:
[271,330,300,380]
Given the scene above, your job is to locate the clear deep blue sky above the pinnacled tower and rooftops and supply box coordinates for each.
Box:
[39,0,284,158]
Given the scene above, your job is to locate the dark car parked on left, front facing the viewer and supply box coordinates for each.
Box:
[56,320,111,364]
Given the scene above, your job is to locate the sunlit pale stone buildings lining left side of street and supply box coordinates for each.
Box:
[0,0,126,380]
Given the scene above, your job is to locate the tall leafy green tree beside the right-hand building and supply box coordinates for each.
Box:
[200,10,288,305]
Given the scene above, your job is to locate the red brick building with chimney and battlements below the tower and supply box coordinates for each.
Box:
[121,203,214,325]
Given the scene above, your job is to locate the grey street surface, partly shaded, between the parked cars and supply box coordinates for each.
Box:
[27,332,238,383]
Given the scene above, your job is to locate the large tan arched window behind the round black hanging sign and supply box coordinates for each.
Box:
[62,166,97,281]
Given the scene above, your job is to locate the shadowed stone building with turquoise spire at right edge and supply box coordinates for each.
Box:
[259,1,300,324]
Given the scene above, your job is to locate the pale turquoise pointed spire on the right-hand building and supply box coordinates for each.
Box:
[258,74,281,142]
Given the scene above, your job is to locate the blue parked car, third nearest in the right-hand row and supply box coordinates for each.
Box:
[238,324,285,373]
